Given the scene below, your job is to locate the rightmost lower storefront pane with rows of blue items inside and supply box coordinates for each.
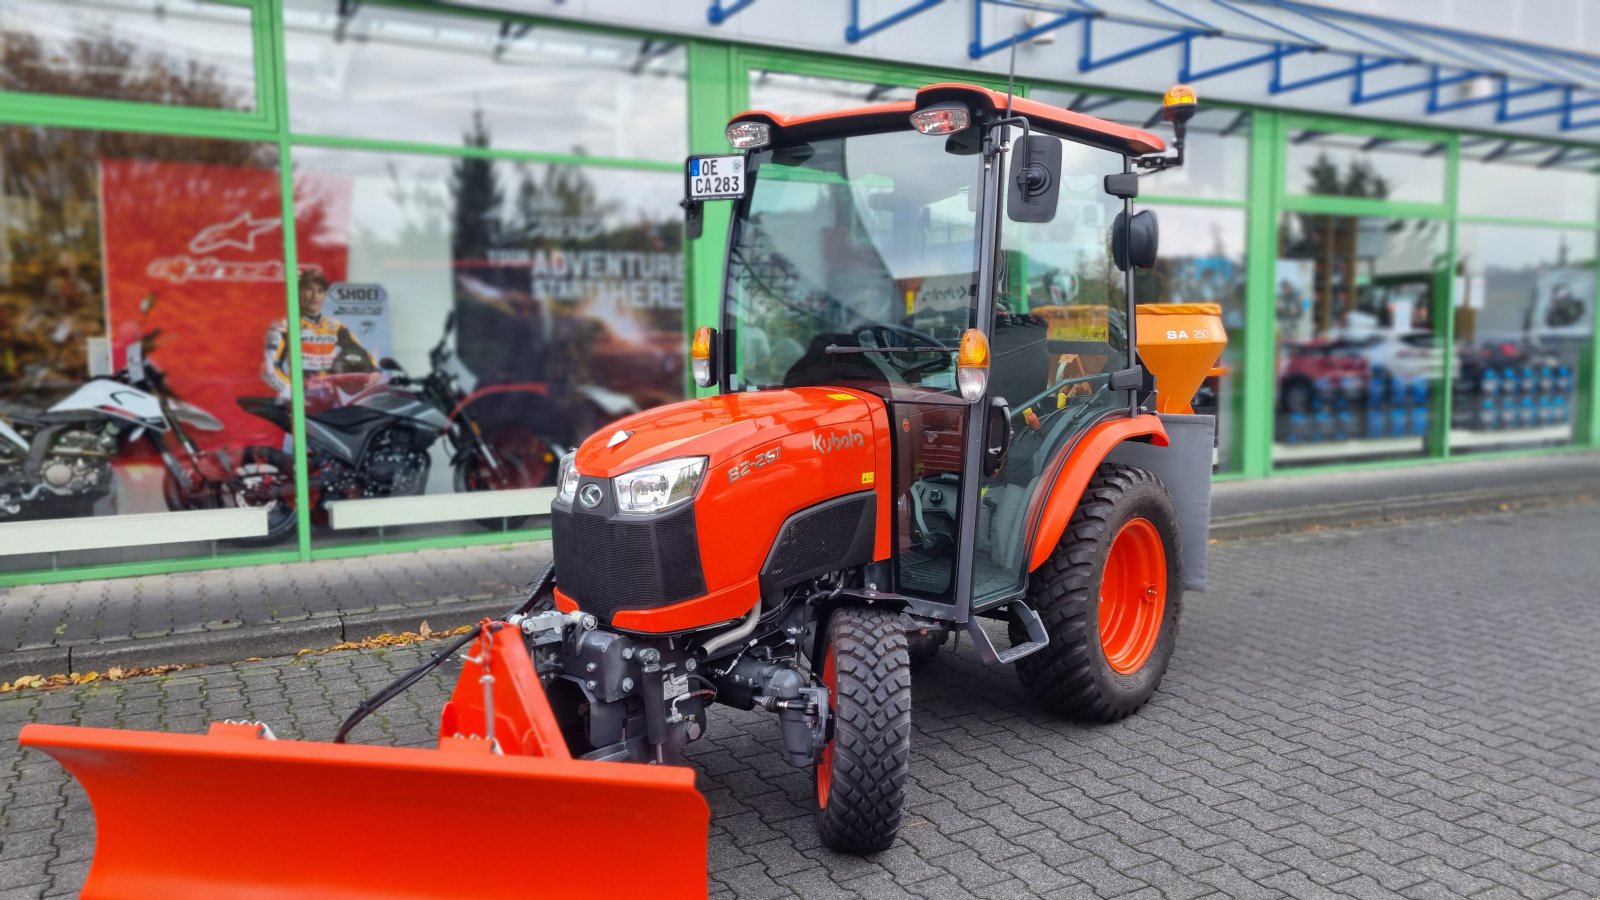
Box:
[1450,224,1595,452]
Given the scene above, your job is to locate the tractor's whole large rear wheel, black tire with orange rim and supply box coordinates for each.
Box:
[1011,463,1182,722]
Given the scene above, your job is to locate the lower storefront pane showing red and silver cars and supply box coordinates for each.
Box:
[1272,213,1451,466]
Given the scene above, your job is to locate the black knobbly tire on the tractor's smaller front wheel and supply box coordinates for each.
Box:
[816,607,910,854]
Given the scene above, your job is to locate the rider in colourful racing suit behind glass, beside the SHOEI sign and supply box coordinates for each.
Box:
[262,269,378,413]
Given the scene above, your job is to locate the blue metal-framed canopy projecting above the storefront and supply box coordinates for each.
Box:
[707,0,1600,131]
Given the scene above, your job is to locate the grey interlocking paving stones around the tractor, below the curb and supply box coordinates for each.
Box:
[0,503,1600,900]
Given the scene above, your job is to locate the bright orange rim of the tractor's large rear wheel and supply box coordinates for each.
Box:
[1099,519,1166,674]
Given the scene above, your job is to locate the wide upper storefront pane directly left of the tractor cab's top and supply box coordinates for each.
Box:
[283,0,688,162]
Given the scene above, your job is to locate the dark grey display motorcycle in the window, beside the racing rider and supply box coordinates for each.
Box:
[235,312,558,543]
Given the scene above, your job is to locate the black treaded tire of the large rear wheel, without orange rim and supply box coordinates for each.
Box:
[1011,463,1182,722]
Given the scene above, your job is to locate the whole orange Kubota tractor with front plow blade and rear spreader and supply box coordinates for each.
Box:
[22,85,1226,897]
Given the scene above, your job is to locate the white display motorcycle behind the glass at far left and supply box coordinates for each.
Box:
[0,293,237,522]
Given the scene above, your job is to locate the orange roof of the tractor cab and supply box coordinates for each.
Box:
[733,83,1166,157]
